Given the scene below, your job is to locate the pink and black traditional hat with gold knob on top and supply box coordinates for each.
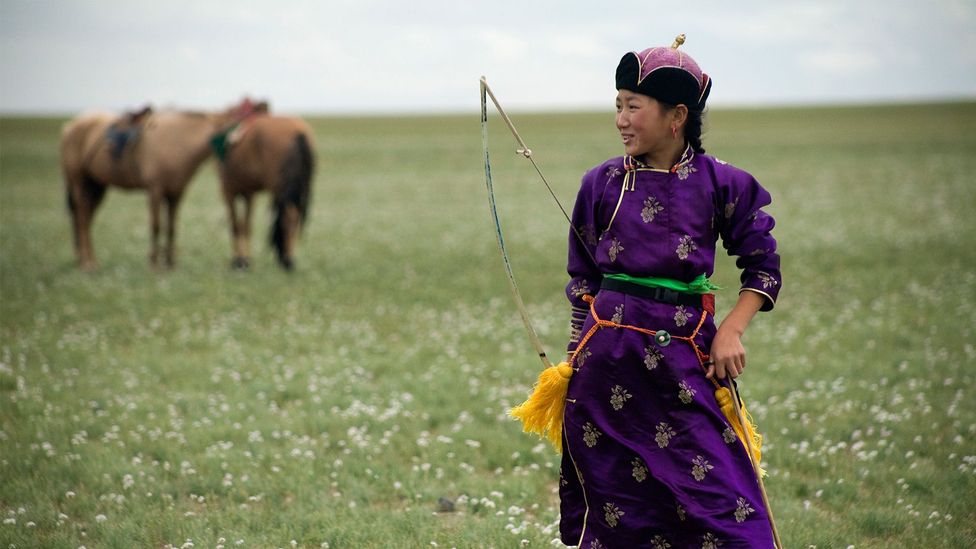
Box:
[617,34,712,111]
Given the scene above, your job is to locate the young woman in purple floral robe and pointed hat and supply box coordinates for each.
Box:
[559,37,781,549]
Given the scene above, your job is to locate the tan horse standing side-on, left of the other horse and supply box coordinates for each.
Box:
[61,110,234,270]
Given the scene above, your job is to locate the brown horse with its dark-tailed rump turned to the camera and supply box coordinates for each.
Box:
[215,112,315,270]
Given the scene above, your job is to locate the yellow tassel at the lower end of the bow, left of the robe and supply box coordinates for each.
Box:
[508,362,573,452]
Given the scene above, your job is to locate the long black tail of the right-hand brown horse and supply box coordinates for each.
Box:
[271,133,315,267]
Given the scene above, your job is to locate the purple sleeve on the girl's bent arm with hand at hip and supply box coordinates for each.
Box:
[718,169,783,311]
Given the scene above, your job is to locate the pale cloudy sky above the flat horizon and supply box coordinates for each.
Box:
[0,0,976,115]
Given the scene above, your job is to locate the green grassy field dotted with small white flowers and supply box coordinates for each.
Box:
[0,99,976,549]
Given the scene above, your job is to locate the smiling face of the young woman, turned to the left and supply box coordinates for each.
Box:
[617,90,672,157]
